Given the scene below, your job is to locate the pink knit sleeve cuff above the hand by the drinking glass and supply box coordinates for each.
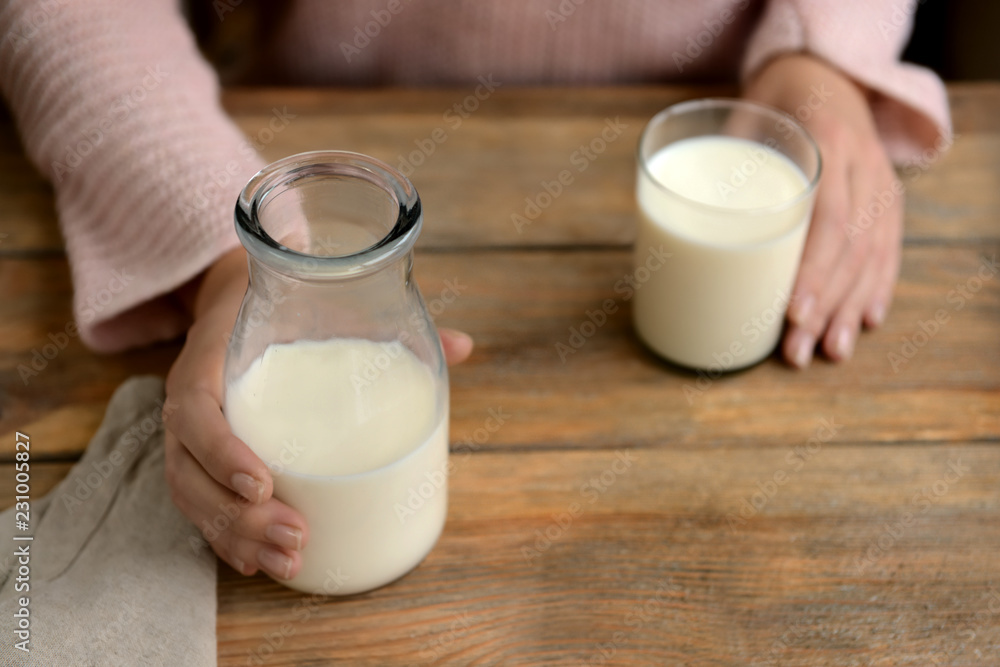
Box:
[741,0,951,163]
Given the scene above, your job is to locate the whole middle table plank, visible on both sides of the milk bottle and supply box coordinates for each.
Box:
[0,244,1000,462]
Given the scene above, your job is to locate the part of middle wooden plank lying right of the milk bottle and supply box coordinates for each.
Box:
[448,247,1000,447]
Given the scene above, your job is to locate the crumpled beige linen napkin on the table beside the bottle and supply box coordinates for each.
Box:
[0,377,216,667]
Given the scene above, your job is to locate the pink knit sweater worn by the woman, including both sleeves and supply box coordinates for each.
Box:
[0,0,950,351]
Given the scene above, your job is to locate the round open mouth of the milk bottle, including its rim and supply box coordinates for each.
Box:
[236,151,423,279]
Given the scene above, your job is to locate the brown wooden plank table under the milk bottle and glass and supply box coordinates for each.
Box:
[0,84,1000,665]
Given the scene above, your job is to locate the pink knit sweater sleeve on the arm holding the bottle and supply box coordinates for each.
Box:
[0,0,262,352]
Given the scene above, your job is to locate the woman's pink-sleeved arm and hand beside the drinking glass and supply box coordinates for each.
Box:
[743,0,951,367]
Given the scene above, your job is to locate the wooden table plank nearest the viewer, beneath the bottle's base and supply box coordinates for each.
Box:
[218,444,1000,666]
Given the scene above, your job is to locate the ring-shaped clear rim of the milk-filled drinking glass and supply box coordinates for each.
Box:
[636,97,823,217]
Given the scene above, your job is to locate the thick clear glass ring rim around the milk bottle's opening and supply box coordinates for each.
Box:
[235,150,423,279]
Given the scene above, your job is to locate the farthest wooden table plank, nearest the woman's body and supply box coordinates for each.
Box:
[0,83,1000,256]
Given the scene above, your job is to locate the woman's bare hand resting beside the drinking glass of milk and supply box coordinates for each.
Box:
[744,54,903,368]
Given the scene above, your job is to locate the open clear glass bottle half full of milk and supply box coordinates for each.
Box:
[224,151,448,595]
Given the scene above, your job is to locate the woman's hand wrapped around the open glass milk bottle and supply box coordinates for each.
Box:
[163,248,472,579]
